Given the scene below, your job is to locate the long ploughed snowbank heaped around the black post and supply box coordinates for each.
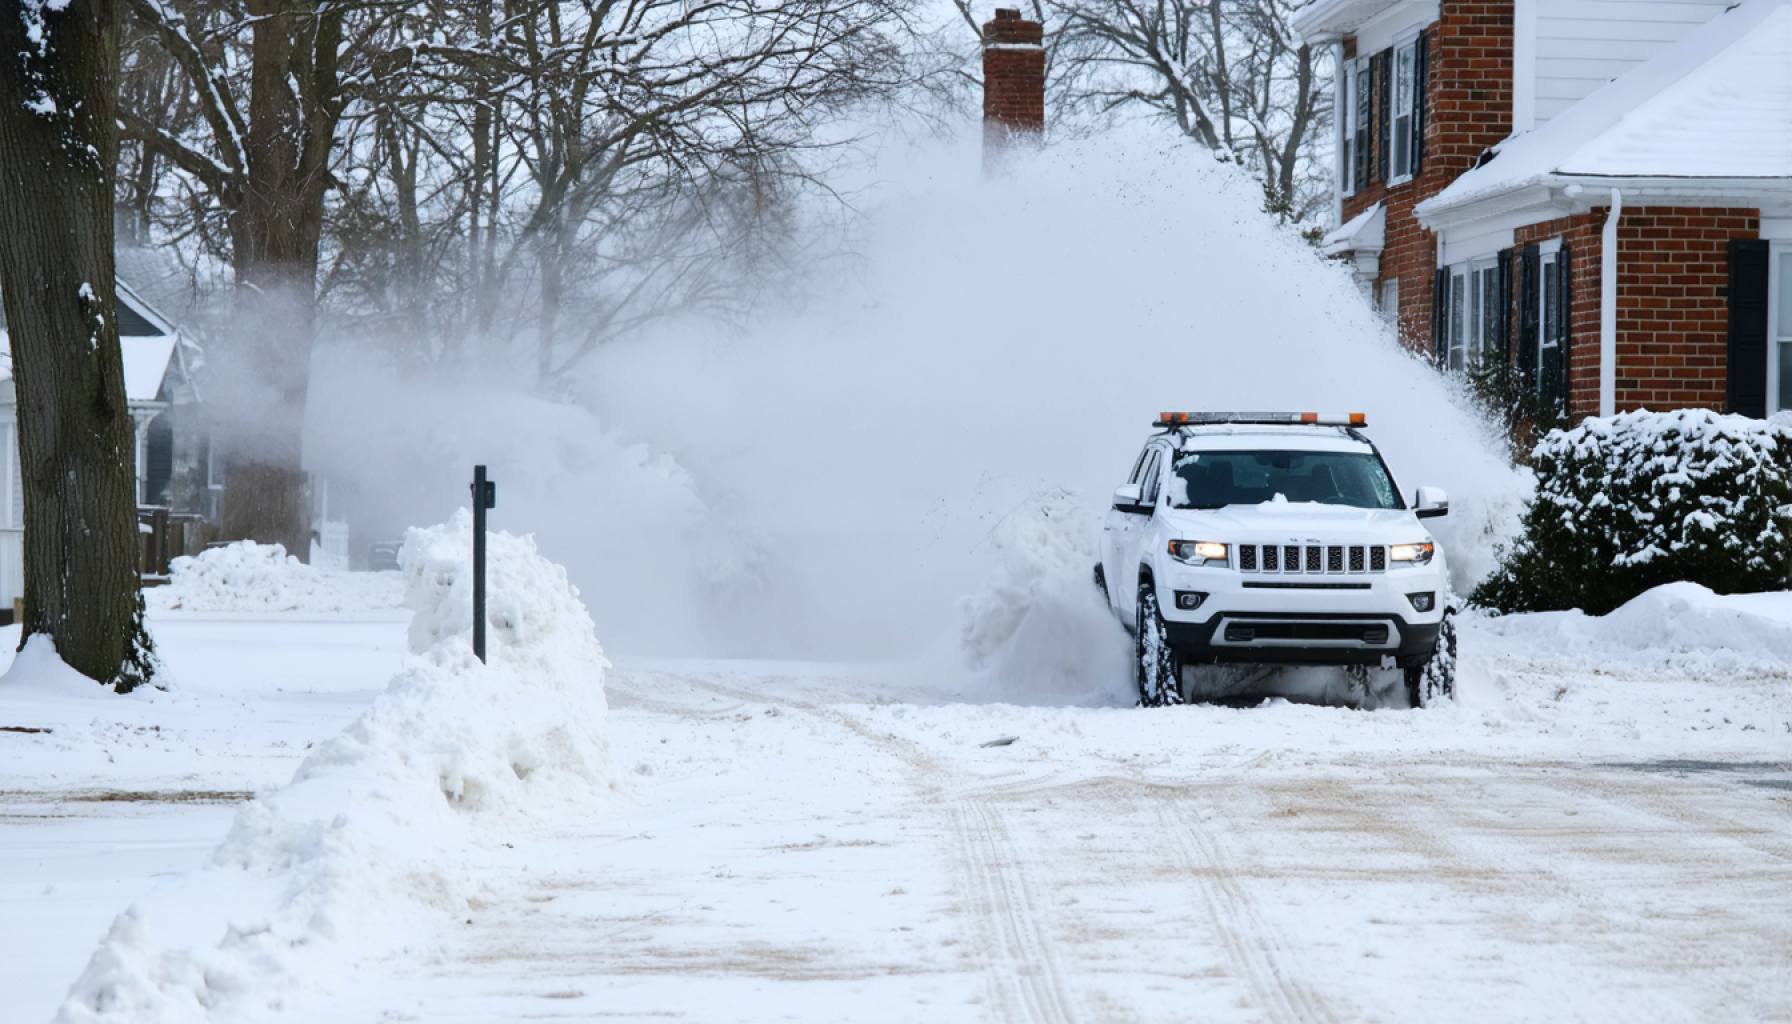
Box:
[57,511,609,1024]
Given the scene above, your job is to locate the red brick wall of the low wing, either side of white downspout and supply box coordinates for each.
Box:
[1516,206,1760,416]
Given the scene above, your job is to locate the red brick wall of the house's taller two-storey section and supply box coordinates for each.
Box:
[1344,0,1512,351]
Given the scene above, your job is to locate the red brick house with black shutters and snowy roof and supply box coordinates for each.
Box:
[1296,0,1792,416]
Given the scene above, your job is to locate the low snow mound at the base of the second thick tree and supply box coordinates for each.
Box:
[143,540,405,613]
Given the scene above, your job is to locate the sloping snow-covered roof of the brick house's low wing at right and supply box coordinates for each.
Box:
[1417,0,1792,217]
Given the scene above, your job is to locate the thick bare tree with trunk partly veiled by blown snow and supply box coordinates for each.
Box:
[120,0,406,558]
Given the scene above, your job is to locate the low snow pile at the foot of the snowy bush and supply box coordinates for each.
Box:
[1469,583,1792,680]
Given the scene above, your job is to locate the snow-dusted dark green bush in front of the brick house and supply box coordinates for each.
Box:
[1475,409,1792,615]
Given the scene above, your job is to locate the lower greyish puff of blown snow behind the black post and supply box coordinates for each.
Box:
[306,346,753,653]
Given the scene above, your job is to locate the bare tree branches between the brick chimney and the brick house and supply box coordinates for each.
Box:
[1048,0,1330,221]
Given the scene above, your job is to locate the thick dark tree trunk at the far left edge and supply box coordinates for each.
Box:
[0,0,156,690]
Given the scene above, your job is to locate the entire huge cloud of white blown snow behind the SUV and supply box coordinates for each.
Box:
[297,127,1521,681]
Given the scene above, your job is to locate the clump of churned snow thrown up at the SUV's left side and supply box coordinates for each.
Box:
[959,491,1136,705]
